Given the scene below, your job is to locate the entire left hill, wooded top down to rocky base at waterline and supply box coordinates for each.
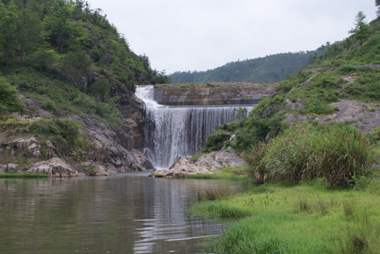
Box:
[0,0,168,177]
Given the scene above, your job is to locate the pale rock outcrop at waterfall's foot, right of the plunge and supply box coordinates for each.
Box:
[150,149,247,177]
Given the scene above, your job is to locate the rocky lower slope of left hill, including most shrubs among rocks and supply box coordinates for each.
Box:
[0,94,153,177]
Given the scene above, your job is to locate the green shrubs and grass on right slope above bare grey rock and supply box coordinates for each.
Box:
[208,16,380,155]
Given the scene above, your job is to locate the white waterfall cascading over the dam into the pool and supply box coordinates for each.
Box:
[136,86,252,169]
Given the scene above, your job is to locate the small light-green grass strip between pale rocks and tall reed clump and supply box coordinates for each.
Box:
[186,167,249,181]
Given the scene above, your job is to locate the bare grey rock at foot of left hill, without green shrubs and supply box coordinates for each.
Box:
[0,96,153,177]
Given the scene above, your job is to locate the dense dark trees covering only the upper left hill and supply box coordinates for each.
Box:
[0,0,168,91]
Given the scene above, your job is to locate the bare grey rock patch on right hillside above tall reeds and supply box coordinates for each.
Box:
[286,100,380,133]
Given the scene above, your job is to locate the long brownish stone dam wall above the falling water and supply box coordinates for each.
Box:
[154,83,275,105]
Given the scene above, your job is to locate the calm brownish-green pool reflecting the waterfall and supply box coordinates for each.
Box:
[0,174,240,254]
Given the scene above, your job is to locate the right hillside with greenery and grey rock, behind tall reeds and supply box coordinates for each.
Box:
[204,12,380,181]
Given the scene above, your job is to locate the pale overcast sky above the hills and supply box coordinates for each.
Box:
[88,0,376,74]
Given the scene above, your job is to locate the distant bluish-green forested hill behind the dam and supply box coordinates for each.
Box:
[170,51,323,84]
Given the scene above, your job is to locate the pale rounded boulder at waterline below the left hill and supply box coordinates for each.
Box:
[26,158,83,177]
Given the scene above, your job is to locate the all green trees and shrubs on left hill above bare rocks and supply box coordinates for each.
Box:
[0,0,169,123]
